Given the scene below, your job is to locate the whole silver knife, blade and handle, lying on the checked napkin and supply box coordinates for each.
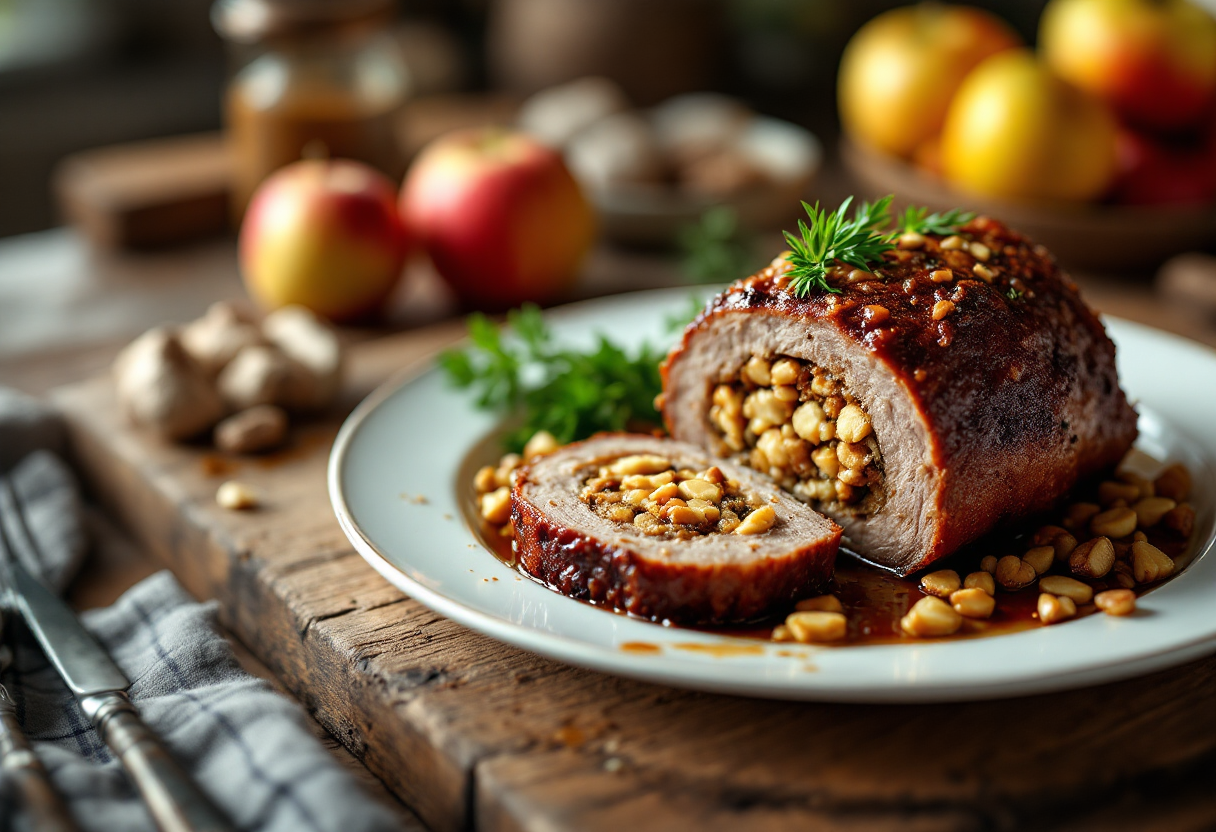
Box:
[0,477,233,832]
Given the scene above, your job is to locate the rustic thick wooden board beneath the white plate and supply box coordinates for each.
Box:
[55,326,1216,832]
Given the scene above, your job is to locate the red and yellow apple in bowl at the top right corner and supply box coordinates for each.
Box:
[1038,0,1216,130]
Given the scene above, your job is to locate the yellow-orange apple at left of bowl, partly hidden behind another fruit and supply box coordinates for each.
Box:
[838,4,1021,157]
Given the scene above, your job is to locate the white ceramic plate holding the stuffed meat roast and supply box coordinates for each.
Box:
[330,289,1216,702]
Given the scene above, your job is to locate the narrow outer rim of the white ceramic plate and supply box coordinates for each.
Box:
[326,287,1216,703]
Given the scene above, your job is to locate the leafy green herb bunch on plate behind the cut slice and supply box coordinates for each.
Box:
[440,305,663,451]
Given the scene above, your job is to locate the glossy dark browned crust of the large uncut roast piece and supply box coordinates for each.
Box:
[663,218,1136,573]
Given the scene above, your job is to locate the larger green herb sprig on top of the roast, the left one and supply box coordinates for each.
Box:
[782,195,895,298]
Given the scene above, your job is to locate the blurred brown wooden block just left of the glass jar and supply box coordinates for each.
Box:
[54,133,232,248]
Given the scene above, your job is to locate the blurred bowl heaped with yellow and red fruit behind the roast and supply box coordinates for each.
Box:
[838,0,1216,270]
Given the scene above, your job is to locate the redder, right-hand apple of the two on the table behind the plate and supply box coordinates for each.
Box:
[401,128,595,309]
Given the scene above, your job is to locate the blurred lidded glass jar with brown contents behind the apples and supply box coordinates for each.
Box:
[212,0,410,217]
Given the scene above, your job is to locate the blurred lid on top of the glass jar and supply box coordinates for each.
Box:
[212,0,396,44]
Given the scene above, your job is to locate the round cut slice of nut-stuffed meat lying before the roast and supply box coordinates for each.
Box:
[511,433,840,623]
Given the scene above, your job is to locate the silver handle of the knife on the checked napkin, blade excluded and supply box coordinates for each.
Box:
[81,692,235,832]
